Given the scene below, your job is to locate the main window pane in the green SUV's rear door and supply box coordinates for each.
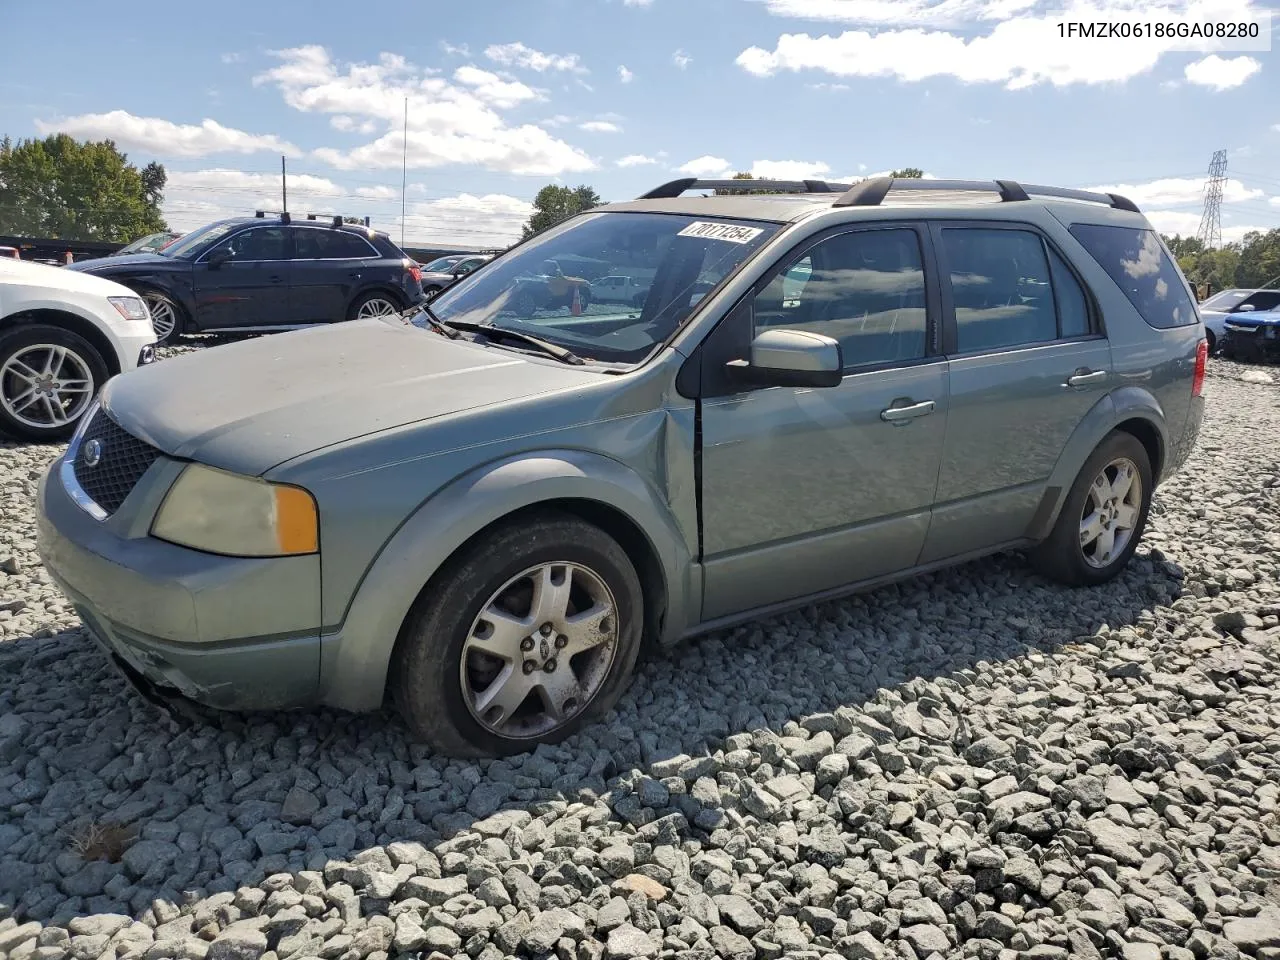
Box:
[942,227,1057,353]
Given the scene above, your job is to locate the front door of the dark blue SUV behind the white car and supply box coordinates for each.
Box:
[192,225,293,330]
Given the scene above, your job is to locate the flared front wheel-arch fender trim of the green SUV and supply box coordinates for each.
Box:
[320,449,696,710]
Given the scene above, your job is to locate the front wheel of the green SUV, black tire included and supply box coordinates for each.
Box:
[389,512,644,756]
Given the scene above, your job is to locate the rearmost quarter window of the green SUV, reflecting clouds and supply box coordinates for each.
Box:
[1071,223,1197,330]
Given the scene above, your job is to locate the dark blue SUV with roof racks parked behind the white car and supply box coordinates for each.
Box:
[67,215,422,343]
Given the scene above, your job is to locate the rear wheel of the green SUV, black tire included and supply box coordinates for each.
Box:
[1030,430,1153,586]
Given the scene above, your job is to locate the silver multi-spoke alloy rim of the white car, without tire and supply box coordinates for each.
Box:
[0,343,95,429]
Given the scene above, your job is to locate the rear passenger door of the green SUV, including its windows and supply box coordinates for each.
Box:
[920,221,1115,563]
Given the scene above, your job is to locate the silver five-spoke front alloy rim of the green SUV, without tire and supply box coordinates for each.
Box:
[460,562,618,737]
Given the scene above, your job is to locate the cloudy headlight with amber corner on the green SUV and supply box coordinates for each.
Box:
[151,463,320,557]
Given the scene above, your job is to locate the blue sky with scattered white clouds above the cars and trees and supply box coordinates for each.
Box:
[0,0,1280,246]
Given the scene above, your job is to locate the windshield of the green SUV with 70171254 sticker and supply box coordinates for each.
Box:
[415,212,778,364]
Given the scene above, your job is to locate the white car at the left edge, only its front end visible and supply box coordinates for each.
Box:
[0,257,155,442]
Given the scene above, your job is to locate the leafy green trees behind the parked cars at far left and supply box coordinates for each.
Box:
[0,133,168,243]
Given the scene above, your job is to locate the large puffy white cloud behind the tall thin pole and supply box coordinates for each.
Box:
[253,46,595,177]
